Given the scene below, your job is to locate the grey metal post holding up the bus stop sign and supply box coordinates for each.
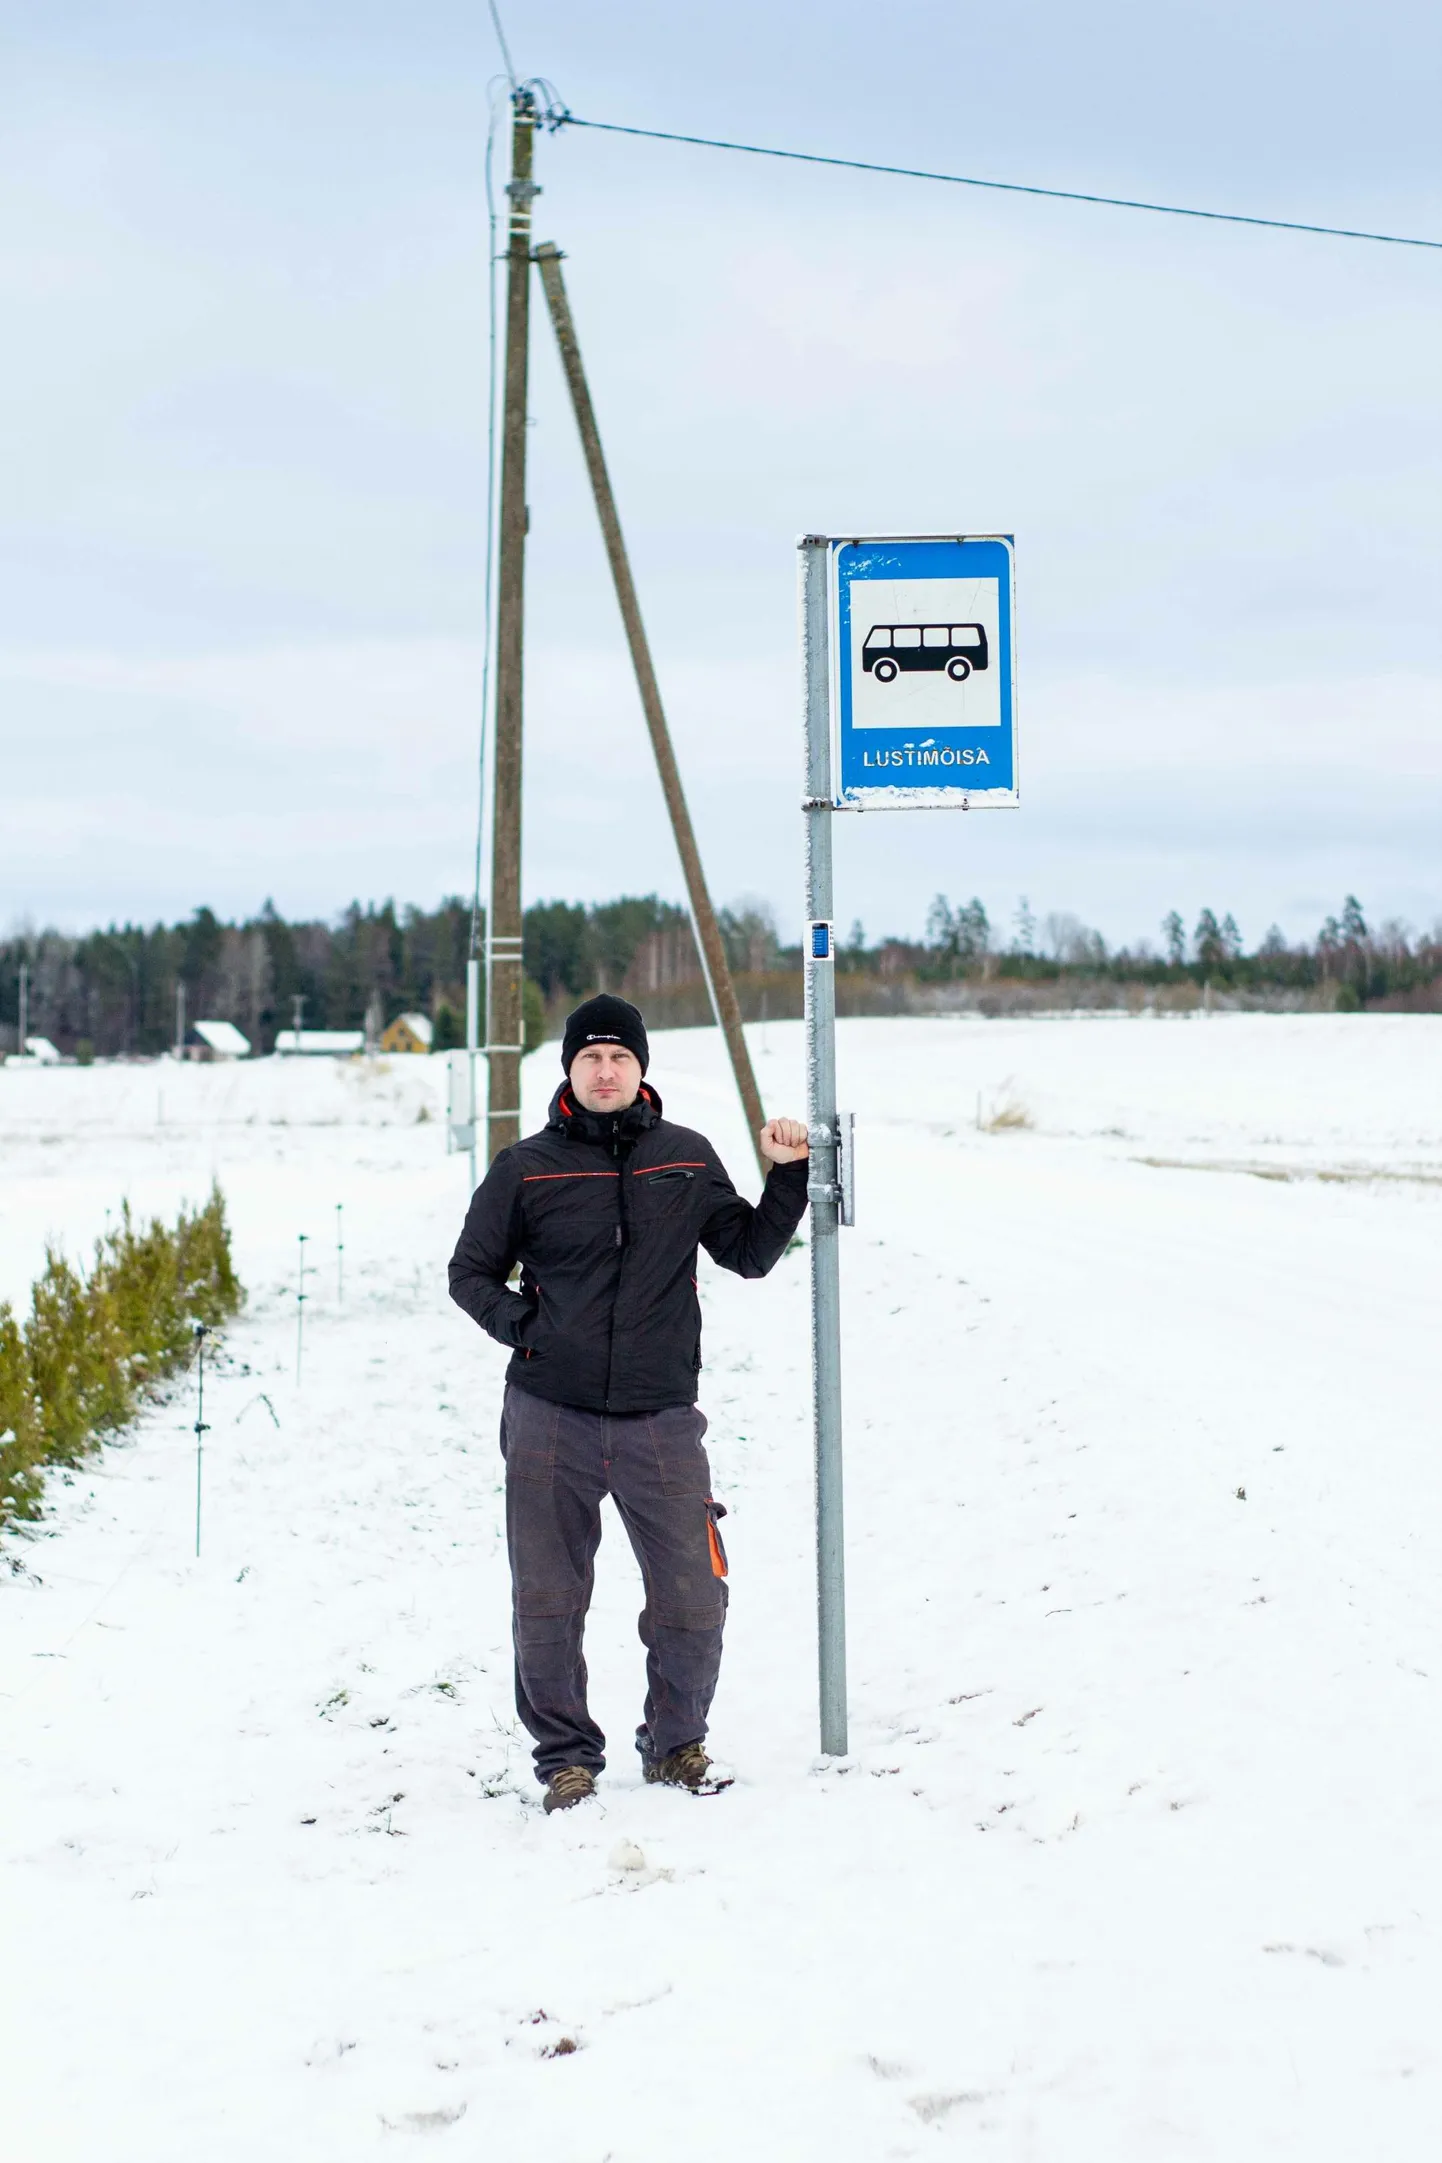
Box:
[800,534,847,1756]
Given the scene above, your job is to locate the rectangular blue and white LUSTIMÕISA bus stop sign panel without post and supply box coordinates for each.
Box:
[828,534,1016,811]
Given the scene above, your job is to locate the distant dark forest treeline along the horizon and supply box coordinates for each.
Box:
[0,893,1442,1058]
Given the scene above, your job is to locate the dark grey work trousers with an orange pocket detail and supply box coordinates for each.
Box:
[502,1386,726,1782]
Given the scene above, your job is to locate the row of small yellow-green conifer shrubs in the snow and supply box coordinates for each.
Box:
[0,1187,244,1525]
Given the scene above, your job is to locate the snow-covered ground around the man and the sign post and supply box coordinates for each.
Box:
[0,1017,1442,2163]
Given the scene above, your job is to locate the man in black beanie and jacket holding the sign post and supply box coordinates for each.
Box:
[450,995,806,1810]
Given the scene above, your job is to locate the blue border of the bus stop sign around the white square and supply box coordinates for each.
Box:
[830,534,1016,809]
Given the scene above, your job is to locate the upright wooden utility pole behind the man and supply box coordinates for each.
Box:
[486,91,540,1164]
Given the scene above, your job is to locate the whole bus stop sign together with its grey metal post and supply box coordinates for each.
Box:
[800,534,1018,1756]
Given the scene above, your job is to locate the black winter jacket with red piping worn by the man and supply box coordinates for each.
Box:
[450,1084,806,1412]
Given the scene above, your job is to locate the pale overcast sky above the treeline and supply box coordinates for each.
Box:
[0,0,1442,943]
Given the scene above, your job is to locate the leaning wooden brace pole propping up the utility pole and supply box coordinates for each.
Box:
[536,240,767,1179]
